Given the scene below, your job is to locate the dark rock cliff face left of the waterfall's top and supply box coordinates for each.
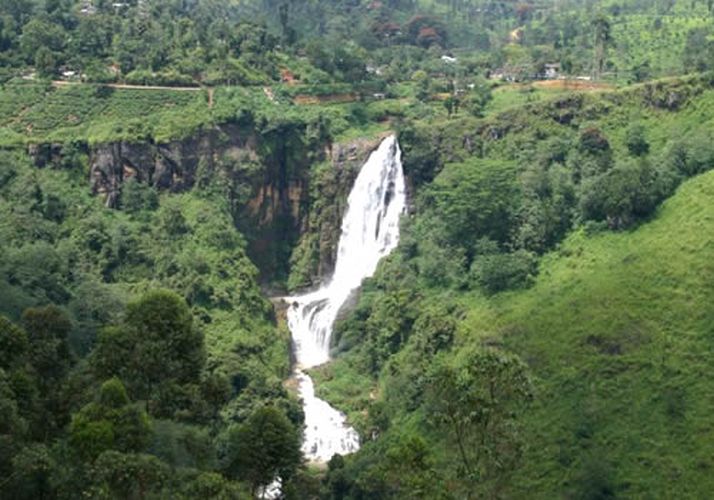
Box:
[28,125,390,288]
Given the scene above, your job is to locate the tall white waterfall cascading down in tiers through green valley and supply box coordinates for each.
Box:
[286,135,406,462]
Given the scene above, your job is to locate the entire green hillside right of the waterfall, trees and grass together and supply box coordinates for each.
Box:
[315,79,714,498]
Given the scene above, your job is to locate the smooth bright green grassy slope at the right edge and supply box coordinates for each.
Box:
[462,173,714,498]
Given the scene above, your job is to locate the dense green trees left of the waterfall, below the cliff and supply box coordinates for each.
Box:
[0,123,302,490]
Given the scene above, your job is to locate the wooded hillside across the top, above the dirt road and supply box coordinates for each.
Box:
[0,0,714,90]
